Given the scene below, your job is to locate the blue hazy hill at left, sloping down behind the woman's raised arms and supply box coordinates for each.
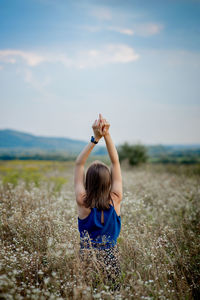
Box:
[0,129,106,155]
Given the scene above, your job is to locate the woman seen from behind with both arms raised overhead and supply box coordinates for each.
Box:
[74,114,122,289]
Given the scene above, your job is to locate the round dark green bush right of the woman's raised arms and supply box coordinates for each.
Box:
[118,143,148,166]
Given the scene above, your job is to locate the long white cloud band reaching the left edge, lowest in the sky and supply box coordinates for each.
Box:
[0,44,139,68]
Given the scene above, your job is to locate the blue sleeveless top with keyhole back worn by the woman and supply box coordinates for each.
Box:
[78,205,121,249]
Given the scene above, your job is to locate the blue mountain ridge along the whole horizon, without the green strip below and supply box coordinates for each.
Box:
[0,128,200,157]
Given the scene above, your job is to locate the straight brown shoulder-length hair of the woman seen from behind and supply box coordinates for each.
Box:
[84,161,111,210]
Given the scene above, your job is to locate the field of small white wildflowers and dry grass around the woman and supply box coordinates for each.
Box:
[0,161,200,299]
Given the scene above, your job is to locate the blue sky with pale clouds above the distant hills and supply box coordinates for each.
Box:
[0,0,200,144]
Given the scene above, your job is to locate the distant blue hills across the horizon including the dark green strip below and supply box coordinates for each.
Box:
[0,129,200,163]
